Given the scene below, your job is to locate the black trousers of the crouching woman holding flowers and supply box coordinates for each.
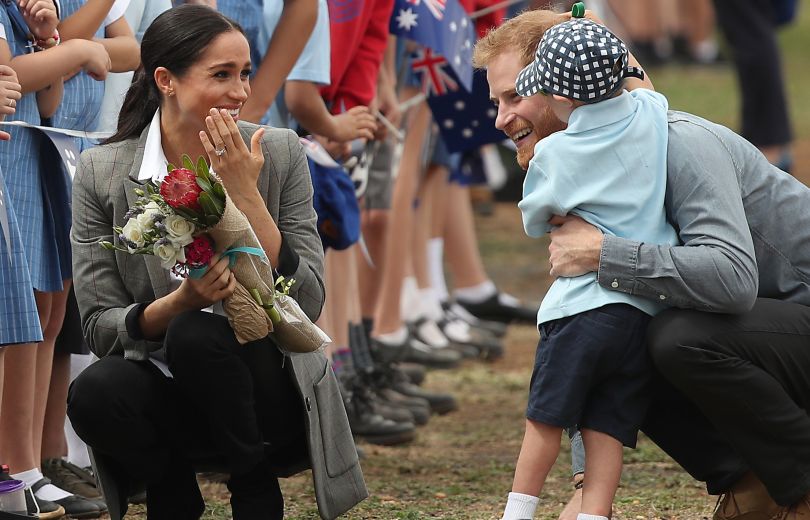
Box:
[68,312,305,519]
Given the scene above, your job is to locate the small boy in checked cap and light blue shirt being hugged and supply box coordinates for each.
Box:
[503,19,677,520]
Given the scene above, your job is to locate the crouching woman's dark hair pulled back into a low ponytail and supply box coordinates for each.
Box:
[104,4,244,143]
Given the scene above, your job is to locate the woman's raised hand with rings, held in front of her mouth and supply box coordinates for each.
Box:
[200,108,264,206]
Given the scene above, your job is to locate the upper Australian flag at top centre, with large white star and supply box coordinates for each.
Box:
[390,0,475,90]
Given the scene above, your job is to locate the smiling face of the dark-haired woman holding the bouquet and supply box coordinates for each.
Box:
[166,30,250,129]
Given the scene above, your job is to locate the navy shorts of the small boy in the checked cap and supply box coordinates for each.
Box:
[526,304,652,448]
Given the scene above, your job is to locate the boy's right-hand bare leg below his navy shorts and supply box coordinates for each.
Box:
[582,429,622,518]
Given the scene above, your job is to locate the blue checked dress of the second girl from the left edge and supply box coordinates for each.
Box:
[0,7,71,292]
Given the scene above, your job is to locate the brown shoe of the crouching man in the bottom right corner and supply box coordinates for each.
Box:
[712,471,784,520]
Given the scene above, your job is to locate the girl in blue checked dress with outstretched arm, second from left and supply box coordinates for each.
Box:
[0,0,117,518]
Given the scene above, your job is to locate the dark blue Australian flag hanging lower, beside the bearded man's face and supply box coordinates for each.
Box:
[422,62,506,153]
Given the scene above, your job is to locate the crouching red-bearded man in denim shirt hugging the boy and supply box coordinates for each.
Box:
[474,11,810,520]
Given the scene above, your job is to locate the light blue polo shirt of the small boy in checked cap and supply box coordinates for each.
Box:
[518,89,678,325]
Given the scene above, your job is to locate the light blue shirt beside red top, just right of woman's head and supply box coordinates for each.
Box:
[259,0,331,128]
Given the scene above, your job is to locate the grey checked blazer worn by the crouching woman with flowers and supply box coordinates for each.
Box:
[71,122,368,519]
